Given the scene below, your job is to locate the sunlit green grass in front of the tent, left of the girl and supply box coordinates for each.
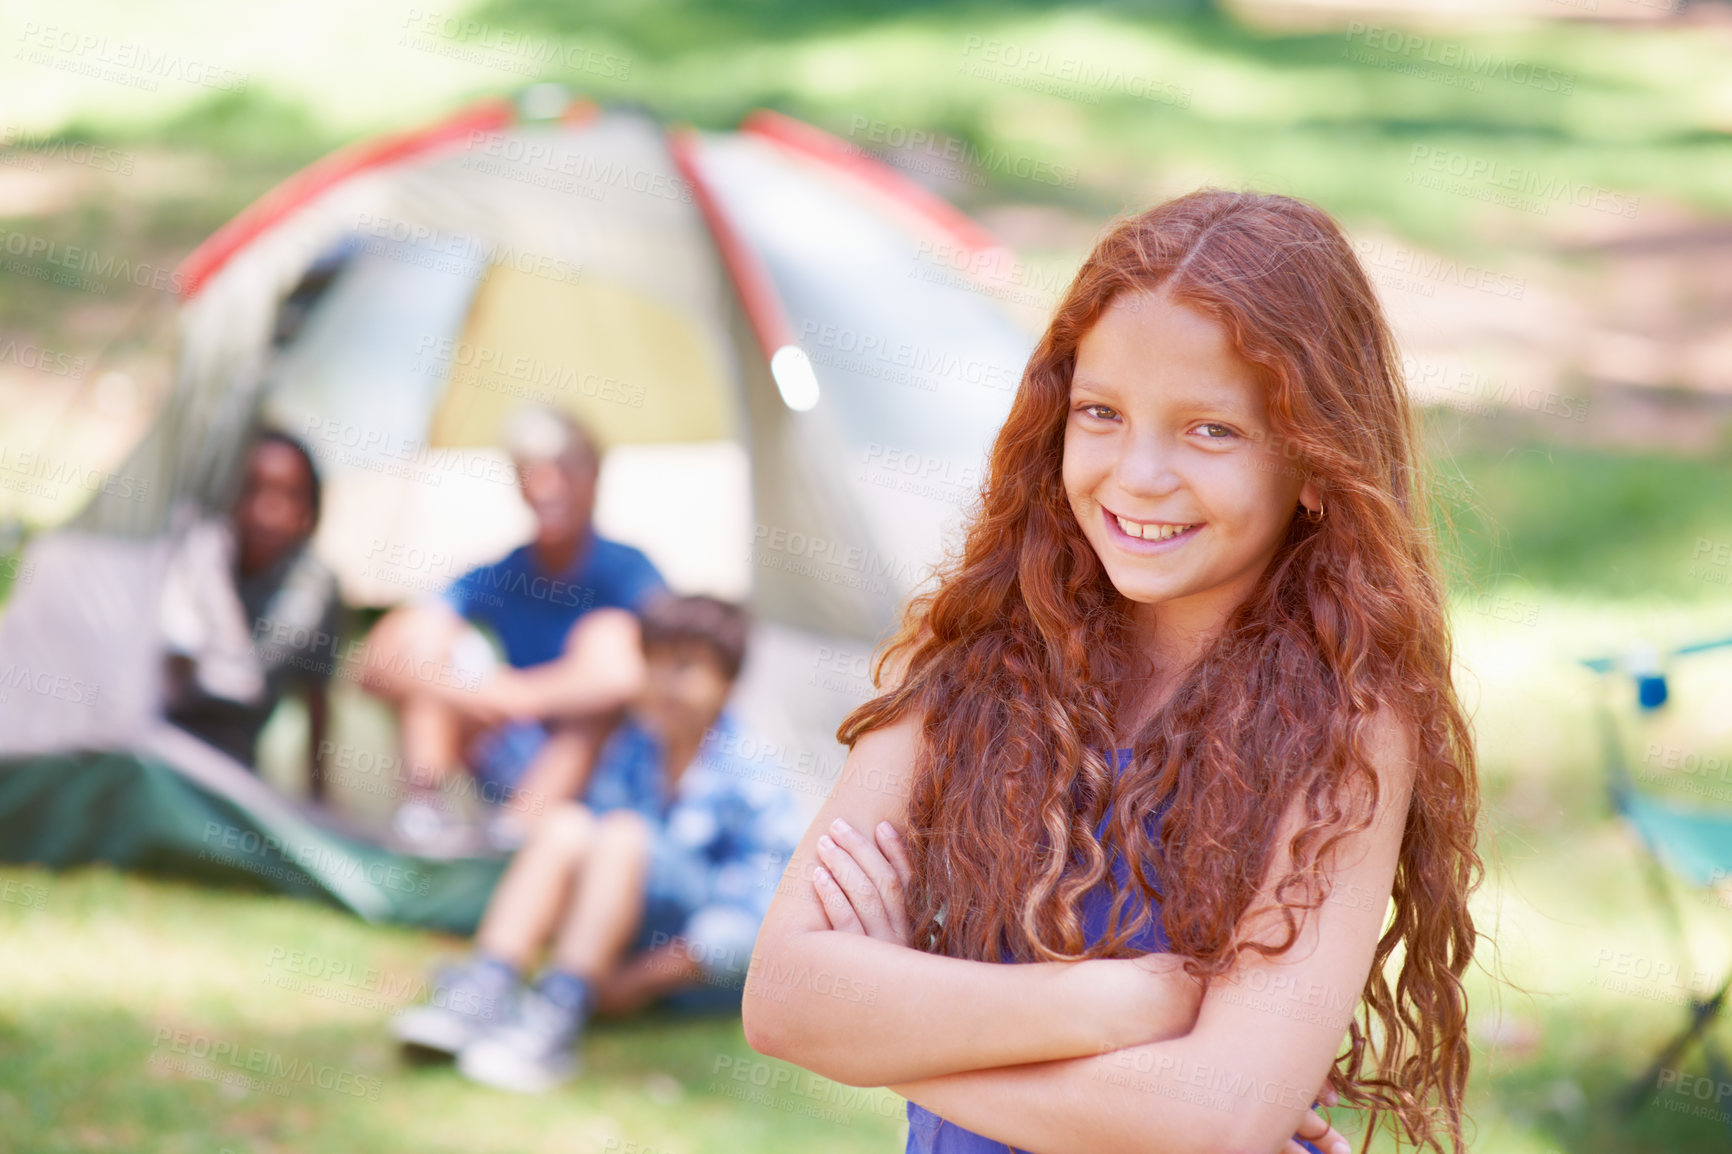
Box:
[0,868,902,1154]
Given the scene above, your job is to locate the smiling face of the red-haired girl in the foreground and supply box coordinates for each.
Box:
[1063,285,1318,629]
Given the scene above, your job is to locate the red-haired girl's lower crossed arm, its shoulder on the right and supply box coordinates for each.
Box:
[890,714,1413,1154]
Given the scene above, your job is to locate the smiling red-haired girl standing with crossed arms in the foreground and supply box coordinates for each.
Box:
[745,191,1481,1154]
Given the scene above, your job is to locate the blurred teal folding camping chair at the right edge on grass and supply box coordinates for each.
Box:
[1581,638,1732,1130]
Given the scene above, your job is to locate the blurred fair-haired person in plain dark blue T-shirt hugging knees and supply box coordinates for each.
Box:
[362,405,667,853]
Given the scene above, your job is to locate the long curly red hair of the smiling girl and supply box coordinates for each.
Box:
[837,189,1483,1154]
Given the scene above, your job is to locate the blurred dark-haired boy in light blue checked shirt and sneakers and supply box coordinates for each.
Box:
[393,594,802,1092]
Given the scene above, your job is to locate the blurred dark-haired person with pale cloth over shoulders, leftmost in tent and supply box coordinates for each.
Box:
[161,430,341,799]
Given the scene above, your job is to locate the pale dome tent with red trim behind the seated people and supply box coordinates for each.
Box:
[0,88,1032,929]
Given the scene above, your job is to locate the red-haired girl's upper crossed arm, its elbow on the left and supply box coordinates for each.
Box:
[743,706,1205,1081]
